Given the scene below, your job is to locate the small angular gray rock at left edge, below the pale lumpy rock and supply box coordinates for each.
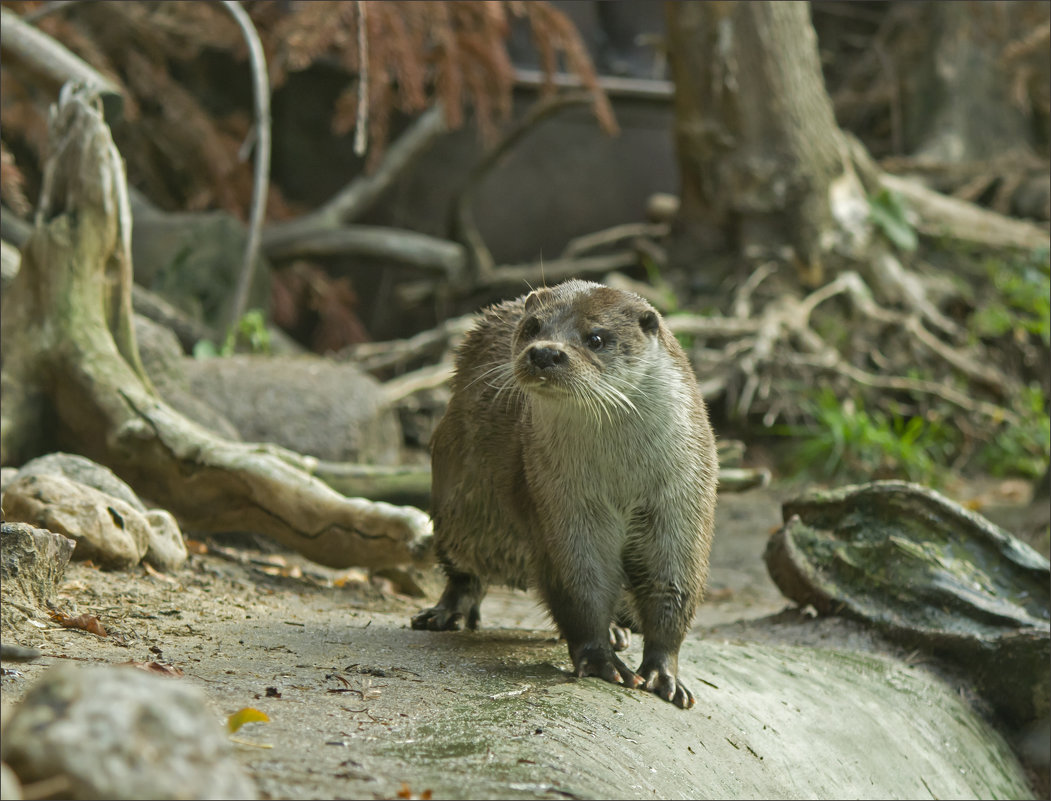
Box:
[0,522,75,630]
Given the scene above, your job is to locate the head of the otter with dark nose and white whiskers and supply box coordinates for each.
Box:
[511,281,660,418]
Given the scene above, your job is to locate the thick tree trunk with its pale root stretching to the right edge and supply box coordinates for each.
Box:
[664,0,1047,288]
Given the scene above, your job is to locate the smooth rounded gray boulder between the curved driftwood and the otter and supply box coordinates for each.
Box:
[185,355,401,465]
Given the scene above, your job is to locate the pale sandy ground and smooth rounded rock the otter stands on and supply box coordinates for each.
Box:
[2,493,1046,799]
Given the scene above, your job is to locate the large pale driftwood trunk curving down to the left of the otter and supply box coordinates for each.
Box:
[0,87,430,567]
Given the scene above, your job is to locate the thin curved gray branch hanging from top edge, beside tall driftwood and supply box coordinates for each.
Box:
[223,0,270,326]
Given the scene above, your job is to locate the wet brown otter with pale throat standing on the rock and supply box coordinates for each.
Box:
[412,281,718,708]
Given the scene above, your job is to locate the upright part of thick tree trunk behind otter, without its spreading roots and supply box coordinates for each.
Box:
[665,2,849,284]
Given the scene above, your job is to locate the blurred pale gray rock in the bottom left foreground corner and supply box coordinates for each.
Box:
[2,664,256,799]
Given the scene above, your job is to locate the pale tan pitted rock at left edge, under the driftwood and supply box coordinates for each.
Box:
[3,475,150,568]
